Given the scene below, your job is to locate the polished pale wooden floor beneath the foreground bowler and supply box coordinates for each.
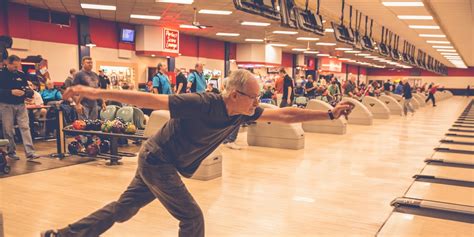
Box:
[0,98,468,237]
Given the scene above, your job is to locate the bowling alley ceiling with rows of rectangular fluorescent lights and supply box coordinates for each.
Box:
[10,0,474,67]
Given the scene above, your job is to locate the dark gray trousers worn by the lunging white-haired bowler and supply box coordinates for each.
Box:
[59,145,204,237]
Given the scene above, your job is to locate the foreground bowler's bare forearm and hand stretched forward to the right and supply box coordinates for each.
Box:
[257,102,355,123]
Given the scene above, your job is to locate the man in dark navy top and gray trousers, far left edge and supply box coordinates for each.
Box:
[0,55,39,160]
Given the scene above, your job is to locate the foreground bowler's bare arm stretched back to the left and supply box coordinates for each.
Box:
[64,86,169,110]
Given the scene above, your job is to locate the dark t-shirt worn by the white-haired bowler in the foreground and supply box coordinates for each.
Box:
[145,93,263,178]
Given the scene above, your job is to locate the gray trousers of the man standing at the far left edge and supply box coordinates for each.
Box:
[0,103,35,157]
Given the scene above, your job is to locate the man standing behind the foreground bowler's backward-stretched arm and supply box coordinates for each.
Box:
[72,56,105,120]
